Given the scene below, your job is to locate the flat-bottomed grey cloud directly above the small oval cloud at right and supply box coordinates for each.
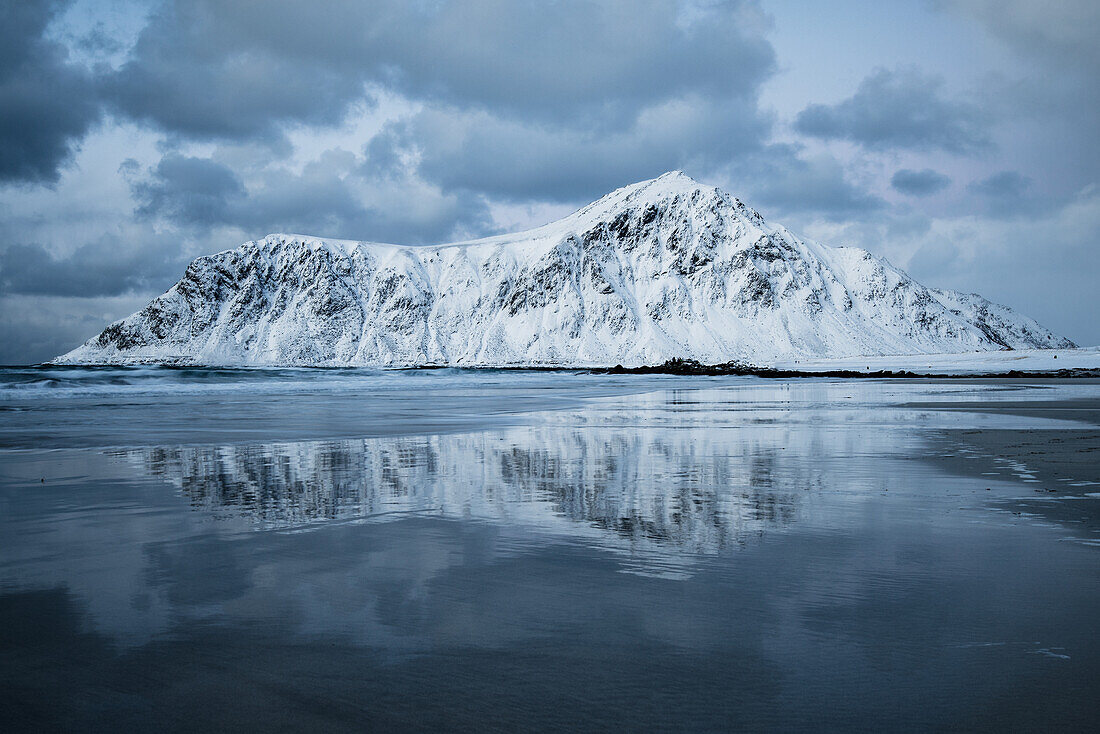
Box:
[794,69,991,153]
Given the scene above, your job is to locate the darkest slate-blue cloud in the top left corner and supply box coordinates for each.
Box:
[0,0,100,183]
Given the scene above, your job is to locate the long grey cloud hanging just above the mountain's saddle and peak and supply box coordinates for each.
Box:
[396,97,769,201]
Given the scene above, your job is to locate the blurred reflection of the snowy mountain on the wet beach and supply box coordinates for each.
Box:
[123,427,815,554]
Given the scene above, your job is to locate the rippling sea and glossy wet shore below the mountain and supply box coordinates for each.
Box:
[0,368,1100,731]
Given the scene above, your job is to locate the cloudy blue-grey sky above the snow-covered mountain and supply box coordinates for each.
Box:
[0,0,1100,364]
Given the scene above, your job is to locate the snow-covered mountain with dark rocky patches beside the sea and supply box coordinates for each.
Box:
[56,172,1073,365]
